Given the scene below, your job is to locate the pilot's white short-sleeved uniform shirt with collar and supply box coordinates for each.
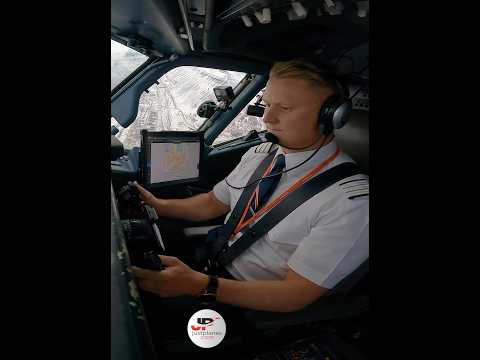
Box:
[213,141,369,289]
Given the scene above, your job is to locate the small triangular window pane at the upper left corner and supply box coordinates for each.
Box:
[110,40,148,90]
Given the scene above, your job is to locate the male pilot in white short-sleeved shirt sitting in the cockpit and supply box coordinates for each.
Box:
[131,59,369,312]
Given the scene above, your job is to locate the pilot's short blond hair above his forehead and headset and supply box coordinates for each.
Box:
[270,58,342,93]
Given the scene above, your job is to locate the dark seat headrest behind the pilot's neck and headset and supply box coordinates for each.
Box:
[335,110,369,174]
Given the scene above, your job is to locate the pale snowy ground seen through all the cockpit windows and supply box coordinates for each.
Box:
[111,40,265,149]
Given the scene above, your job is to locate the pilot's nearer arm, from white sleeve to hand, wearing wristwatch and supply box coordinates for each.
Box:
[129,188,368,312]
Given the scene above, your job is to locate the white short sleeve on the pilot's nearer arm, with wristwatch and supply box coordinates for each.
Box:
[288,196,369,289]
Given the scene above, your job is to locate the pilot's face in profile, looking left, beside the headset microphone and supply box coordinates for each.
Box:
[263,78,332,148]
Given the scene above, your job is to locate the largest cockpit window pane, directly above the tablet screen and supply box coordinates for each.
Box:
[116,66,246,148]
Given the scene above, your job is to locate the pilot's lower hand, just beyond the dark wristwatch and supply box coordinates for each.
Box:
[130,255,208,297]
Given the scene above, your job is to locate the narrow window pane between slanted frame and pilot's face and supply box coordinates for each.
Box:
[213,89,266,145]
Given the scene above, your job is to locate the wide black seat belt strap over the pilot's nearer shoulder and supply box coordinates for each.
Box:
[217,162,361,266]
